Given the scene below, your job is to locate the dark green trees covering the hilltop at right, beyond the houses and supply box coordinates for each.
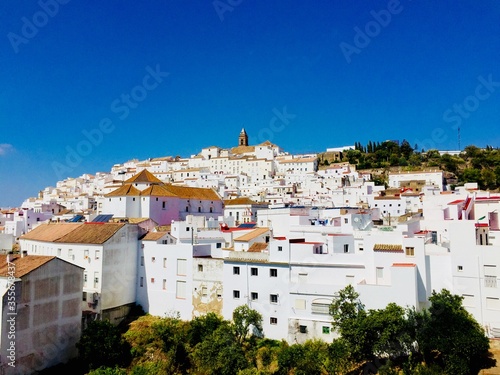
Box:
[318,140,500,190]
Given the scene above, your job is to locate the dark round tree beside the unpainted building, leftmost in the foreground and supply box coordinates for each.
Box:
[76,320,129,370]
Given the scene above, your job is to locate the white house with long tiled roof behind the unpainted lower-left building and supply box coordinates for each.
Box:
[20,223,142,323]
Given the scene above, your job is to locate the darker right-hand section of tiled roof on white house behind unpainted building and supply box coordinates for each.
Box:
[55,223,125,244]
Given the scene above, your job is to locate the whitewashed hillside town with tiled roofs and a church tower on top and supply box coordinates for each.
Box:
[0,129,500,373]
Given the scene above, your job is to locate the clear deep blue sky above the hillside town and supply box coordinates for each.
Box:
[0,0,500,207]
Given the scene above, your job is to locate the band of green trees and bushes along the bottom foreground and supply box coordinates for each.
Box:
[69,286,494,375]
